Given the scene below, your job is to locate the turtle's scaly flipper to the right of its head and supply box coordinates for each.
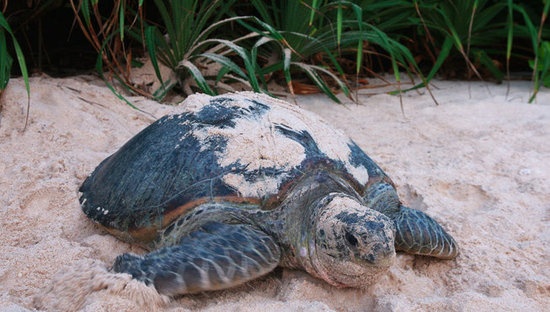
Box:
[394,206,458,259]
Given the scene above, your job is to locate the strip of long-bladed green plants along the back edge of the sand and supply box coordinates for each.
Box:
[0,0,550,106]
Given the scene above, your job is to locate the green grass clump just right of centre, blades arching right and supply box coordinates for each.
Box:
[245,1,432,102]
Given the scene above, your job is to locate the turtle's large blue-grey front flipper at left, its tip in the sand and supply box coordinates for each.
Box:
[113,222,281,295]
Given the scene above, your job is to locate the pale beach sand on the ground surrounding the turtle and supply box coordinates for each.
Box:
[0,77,550,311]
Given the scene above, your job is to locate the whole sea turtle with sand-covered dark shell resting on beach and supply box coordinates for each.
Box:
[80,92,458,295]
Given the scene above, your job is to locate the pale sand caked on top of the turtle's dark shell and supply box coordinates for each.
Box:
[174,92,368,197]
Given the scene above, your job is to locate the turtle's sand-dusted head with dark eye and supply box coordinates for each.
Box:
[309,194,395,287]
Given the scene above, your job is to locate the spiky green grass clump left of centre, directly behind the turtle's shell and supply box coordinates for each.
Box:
[71,0,272,100]
